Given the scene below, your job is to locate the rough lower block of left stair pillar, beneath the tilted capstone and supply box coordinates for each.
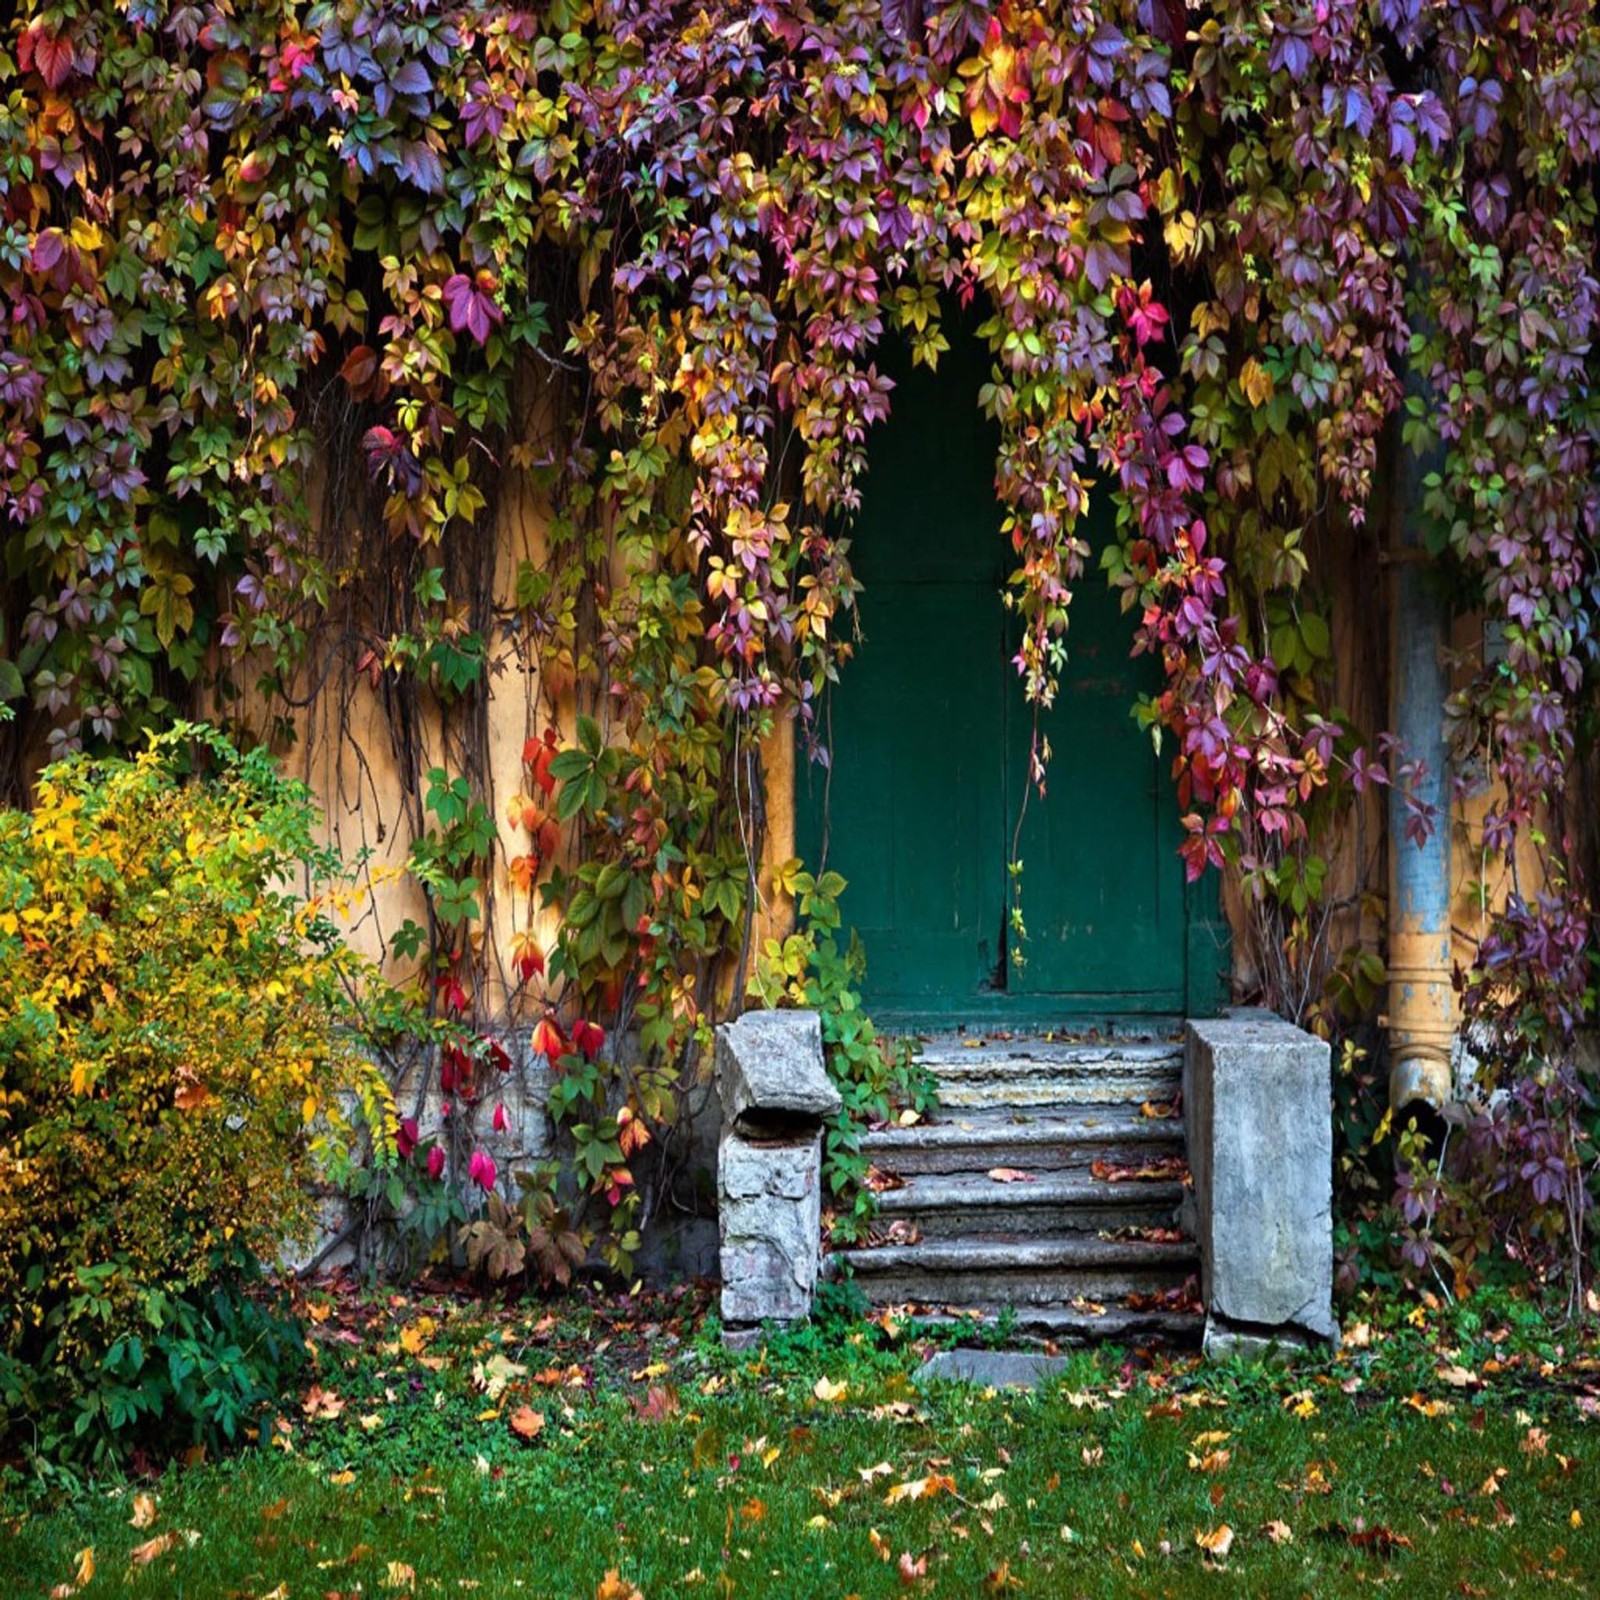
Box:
[717,1133,822,1326]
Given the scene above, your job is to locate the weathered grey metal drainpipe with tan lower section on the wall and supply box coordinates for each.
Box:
[1387,419,1456,1110]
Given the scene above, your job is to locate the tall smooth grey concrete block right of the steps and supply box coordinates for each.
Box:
[1184,1011,1339,1354]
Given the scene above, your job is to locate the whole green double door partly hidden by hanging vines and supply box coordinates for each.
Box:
[798,328,1192,1026]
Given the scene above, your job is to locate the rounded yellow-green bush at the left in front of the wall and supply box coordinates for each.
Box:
[0,726,392,1459]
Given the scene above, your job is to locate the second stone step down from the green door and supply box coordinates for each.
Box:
[861,1106,1184,1178]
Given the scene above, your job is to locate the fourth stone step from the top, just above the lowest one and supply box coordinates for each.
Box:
[838,1234,1198,1309]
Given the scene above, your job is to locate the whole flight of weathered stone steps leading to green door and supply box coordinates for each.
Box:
[838,1034,1203,1344]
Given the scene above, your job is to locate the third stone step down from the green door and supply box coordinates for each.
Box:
[877,1168,1184,1240]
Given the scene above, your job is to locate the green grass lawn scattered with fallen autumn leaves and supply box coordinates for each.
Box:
[0,1291,1600,1600]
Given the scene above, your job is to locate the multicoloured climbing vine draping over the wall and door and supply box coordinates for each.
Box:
[0,0,1600,1273]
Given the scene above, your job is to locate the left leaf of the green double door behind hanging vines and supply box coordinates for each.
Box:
[800,326,1006,1010]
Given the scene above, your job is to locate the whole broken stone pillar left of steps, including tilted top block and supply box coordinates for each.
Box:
[717,1011,843,1339]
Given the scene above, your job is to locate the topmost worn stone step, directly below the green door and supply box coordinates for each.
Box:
[920,1035,1184,1107]
